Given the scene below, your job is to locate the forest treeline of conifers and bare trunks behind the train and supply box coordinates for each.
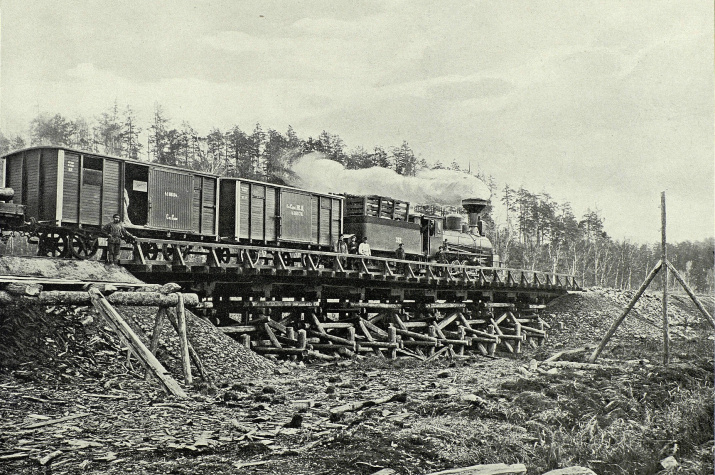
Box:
[0,103,715,292]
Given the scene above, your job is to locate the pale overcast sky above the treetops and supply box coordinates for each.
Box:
[0,0,715,242]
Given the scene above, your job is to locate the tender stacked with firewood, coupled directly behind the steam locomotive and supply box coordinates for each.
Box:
[343,195,423,257]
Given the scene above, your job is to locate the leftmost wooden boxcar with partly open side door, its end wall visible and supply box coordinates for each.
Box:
[5,146,218,238]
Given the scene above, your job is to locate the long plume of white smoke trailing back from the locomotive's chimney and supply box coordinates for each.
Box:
[288,152,491,206]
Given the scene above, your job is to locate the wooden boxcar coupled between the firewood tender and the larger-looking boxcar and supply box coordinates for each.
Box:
[219,178,343,250]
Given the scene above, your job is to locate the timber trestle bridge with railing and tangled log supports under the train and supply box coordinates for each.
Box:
[116,238,579,360]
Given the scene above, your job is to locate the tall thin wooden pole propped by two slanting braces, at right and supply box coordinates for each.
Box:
[588,191,715,365]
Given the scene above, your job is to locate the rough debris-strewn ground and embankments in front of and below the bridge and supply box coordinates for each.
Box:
[0,289,713,475]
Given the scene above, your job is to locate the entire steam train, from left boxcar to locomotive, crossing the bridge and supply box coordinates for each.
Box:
[0,146,495,266]
